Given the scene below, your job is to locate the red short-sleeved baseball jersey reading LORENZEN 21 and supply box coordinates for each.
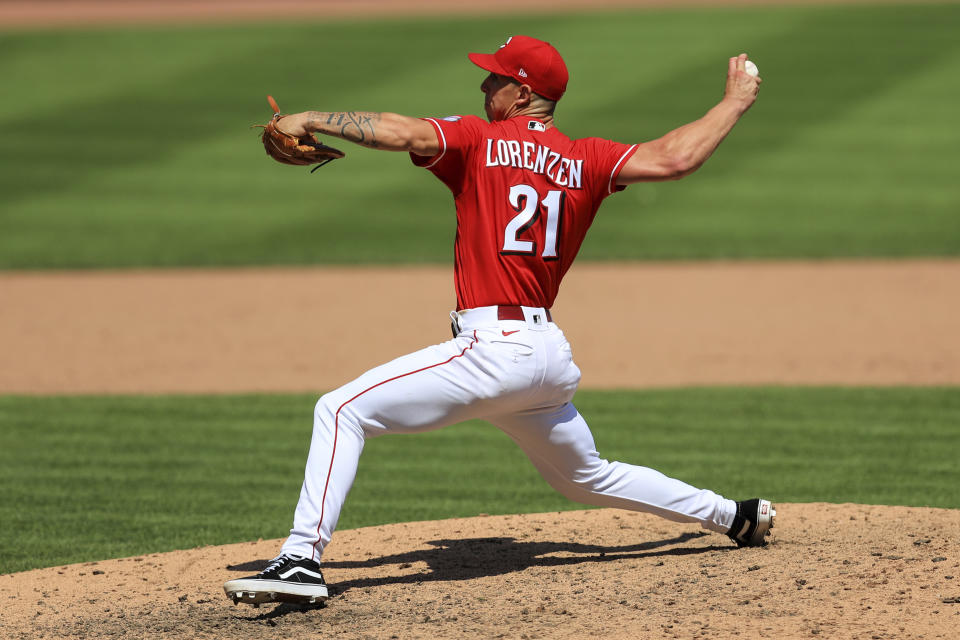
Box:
[411,116,637,310]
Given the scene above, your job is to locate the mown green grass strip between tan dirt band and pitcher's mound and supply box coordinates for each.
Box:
[0,388,960,573]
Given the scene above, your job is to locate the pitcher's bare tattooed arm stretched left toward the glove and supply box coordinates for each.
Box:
[277,111,440,156]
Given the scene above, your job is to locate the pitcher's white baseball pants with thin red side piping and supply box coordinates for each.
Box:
[282,307,736,561]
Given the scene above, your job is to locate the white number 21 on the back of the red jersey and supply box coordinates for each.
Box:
[500,184,566,260]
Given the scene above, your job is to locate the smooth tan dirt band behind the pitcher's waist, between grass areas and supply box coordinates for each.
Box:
[0,260,960,393]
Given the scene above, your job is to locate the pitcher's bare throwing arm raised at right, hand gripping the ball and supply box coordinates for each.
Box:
[617,53,761,185]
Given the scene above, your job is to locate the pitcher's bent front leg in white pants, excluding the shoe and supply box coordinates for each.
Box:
[282,334,532,561]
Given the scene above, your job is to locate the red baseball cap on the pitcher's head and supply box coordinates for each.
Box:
[468,36,569,100]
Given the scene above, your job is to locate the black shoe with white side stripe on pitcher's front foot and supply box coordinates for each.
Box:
[223,554,328,605]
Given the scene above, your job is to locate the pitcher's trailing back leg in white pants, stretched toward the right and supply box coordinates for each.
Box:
[492,403,737,533]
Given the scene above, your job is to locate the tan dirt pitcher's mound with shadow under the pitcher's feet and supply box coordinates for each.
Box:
[0,504,960,639]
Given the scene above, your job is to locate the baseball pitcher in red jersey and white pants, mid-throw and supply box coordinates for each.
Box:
[224,36,775,604]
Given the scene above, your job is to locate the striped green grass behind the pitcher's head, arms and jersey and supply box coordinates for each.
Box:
[0,5,960,269]
